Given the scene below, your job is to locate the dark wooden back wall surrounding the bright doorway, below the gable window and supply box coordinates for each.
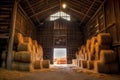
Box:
[37,20,83,63]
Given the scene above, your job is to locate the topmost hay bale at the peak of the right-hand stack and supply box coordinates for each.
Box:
[97,33,112,45]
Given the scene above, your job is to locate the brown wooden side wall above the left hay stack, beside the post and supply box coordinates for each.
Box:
[15,6,36,39]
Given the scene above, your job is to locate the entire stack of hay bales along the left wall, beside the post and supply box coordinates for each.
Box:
[12,33,43,71]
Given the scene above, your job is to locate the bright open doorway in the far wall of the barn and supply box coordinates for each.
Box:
[53,48,67,65]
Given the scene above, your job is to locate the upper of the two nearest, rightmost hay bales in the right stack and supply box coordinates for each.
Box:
[100,50,116,64]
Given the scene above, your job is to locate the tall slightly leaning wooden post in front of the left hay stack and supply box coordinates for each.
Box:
[7,0,17,70]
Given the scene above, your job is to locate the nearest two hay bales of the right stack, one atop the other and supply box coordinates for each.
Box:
[94,50,119,73]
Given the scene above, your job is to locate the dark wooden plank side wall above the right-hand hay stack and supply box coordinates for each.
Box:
[85,0,120,63]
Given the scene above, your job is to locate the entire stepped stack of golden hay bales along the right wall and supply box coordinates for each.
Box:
[75,33,119,73]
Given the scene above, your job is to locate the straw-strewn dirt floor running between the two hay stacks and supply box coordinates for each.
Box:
[0,65,120,80]
